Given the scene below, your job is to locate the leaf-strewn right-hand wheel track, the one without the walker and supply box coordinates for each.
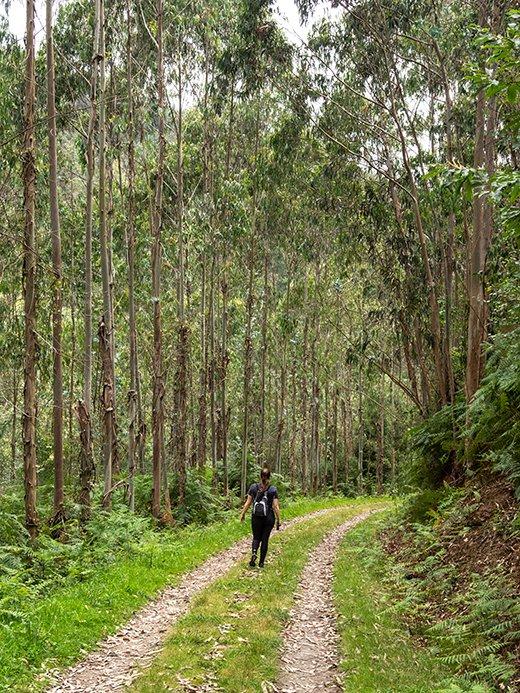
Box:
[275,509,379,693]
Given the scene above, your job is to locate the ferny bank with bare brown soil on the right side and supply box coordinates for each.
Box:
[384,482,520,692]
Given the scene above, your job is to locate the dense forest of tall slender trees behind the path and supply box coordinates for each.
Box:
[0,0,520,524]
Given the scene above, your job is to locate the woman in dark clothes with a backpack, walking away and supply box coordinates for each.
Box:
[240,467,280,568]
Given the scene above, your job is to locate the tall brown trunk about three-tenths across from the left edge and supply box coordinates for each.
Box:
[152,0,167,518]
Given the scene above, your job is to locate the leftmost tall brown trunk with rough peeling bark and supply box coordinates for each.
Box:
[22,0,38,539]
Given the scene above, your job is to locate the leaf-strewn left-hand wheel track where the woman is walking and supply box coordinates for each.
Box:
[48,508,344,693]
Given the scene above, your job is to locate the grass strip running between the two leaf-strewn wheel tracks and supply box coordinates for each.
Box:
[133,500,388,693]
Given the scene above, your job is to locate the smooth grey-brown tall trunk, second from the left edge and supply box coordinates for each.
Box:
[45,0,65,524]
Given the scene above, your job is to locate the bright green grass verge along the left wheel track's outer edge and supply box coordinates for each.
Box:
[0,498,358,691]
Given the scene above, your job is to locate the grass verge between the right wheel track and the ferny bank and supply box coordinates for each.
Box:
[334,516,468,693]
